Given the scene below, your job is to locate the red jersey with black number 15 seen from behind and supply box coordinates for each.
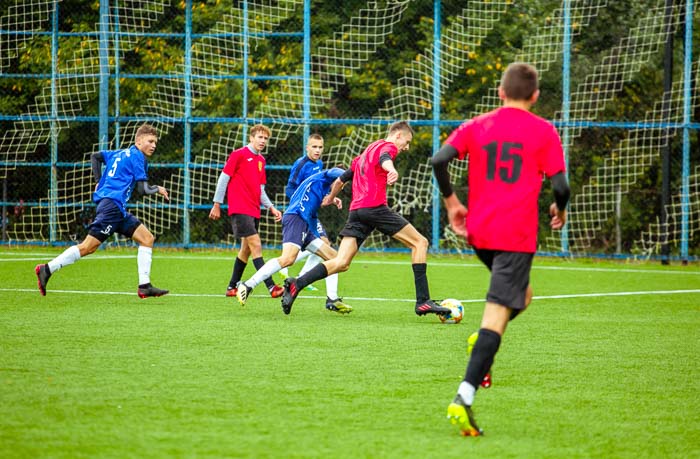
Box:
[445,107,566,253]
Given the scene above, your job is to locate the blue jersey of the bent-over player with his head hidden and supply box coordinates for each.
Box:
[284,167,345,236]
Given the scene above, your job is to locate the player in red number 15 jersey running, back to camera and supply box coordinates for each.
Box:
[432,62,570,436]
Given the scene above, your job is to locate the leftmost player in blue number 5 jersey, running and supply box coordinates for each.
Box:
[34,124,170,298]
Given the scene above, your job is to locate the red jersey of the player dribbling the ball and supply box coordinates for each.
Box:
[350,140,399,210]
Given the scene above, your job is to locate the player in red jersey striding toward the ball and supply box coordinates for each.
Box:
[282,121,450,316]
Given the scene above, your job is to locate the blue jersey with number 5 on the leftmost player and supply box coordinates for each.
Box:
[92,145,148,216]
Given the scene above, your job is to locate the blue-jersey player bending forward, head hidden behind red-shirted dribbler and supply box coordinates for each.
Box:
[236,167,352,314]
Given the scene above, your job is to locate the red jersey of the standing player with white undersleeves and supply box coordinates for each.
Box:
[224,146,267,218]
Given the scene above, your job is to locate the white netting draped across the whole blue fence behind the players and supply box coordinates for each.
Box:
[0,0,700,254]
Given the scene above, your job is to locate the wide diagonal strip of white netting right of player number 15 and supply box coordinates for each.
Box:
[547,1,696,252]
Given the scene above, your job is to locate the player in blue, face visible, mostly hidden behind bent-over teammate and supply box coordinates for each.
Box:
[280,134,331,291]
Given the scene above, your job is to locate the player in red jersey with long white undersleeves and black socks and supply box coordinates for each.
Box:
[209,124,282,298]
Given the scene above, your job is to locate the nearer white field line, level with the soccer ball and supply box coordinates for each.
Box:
[0,288,700,304]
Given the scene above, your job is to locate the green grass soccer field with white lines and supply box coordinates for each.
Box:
[0,248,700,459]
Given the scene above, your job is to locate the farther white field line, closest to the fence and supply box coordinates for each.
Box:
[0,252,700,276]
